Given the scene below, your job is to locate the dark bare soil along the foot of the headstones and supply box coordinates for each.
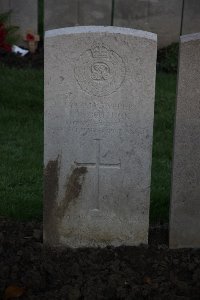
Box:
[0,218,200,300]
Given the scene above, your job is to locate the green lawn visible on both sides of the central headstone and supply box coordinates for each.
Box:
[0,66,176,222]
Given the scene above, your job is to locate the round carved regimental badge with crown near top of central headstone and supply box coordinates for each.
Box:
[74,43,125,96]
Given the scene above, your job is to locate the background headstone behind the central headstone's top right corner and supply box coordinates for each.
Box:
[114,0,182,48]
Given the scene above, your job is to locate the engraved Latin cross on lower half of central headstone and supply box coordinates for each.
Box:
[74,139,121,210]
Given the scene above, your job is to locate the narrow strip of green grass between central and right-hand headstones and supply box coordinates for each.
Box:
[150,73,176,222]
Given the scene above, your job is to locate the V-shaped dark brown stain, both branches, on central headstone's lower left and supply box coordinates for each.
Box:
[44,163,87,246]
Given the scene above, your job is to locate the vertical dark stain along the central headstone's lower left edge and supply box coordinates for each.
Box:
[44,156,59,245]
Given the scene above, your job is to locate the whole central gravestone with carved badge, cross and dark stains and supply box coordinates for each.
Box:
[44,26,157,247]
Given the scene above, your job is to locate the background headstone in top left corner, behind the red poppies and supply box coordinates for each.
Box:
[0,0,38,44]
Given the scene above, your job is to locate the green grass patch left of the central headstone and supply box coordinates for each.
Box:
[0,65,43,220]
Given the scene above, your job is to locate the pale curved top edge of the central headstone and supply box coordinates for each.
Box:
[45,26,157,41]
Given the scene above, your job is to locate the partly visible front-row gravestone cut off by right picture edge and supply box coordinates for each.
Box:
[170,33,200,248]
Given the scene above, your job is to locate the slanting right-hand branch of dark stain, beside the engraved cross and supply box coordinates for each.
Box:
[58,167,87,218]
